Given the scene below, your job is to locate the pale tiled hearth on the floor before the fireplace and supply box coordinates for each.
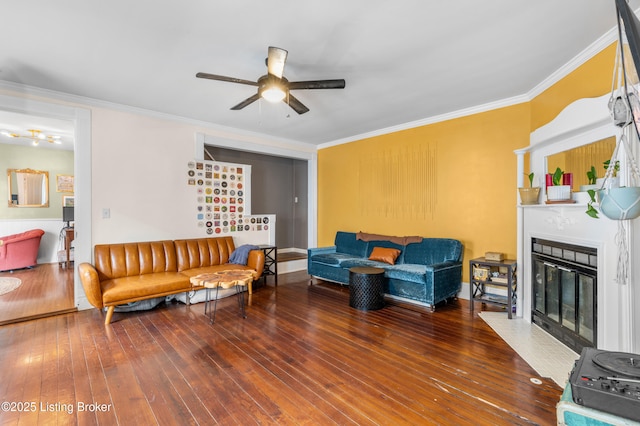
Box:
[479,312,580,388]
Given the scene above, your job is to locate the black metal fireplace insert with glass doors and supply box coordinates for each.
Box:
[531,238,598,353]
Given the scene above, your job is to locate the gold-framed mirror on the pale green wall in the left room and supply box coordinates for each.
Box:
[7,169,49,207]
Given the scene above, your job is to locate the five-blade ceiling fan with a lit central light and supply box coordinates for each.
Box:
[196,46,345,114]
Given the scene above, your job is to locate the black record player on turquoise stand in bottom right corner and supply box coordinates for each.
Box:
[569,348,640,421]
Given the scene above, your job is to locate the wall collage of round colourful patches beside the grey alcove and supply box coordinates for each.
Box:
[187,161,270,235]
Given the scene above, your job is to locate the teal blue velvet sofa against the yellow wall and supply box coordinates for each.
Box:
[307,231,463,310]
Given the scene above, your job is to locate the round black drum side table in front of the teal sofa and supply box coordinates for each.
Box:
[349,266,384,311]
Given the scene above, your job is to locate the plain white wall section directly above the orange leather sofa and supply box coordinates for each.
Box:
[91,109,202,245]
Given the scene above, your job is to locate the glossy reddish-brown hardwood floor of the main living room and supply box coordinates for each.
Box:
[0,272,562,425]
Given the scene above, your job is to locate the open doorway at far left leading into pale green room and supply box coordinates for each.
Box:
[0,111,75,324]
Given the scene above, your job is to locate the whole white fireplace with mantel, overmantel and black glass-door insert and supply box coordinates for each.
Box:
[515,94,640,353]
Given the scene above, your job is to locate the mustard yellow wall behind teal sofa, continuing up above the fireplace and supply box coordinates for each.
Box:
[318,39,615,281]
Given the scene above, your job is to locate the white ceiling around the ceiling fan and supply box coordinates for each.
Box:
[0,0,640,145]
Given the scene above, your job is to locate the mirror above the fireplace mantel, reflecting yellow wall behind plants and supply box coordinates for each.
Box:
[547,136,616,191]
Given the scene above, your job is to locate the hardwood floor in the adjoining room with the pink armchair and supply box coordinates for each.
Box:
[0,263,76,325]
